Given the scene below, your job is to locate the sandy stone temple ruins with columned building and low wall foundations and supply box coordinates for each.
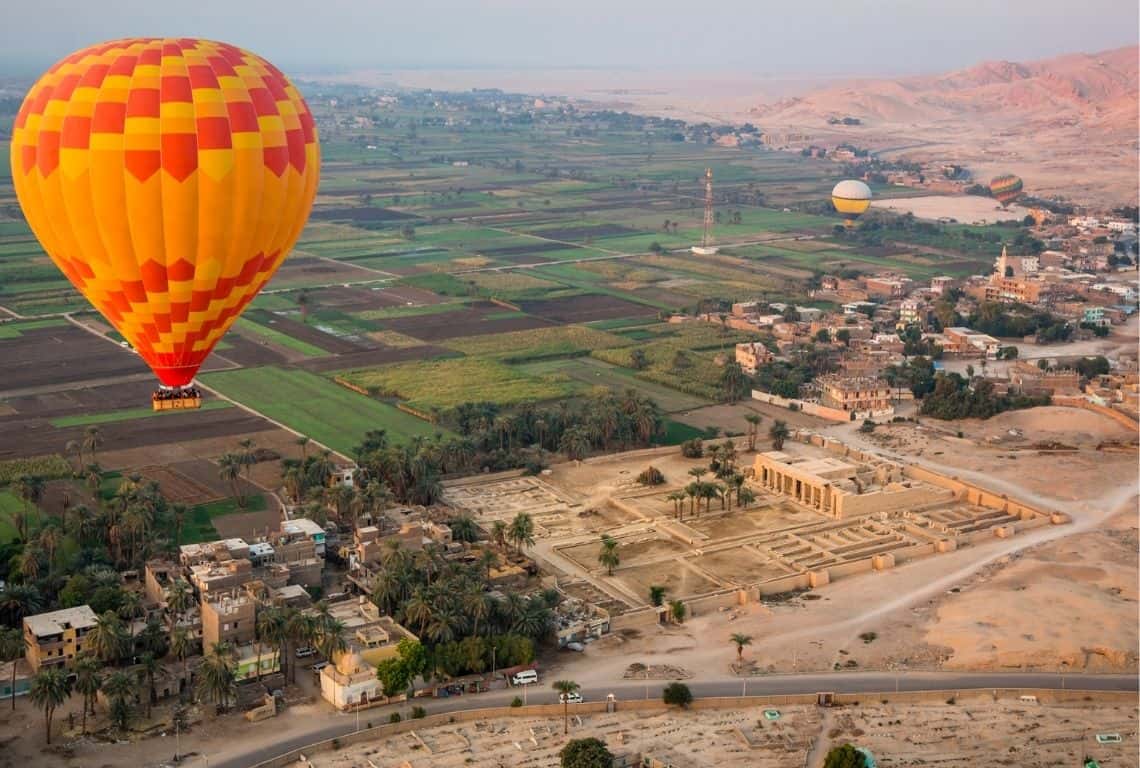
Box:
[445,431,1068,629]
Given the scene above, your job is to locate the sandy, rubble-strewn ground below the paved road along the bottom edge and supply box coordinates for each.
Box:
[310,696,1137,768]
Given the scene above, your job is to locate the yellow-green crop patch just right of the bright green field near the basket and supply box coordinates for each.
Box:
[343,360,577,410]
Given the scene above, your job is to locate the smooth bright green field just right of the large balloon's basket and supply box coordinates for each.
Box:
[201,366,439,454]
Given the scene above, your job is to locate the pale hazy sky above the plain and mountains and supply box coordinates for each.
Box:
[0,0,1140,76]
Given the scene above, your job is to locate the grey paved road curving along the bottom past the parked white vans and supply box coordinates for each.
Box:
[209,672,1138,768]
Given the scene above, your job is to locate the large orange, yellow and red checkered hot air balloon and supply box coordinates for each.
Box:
[11,38,319,407]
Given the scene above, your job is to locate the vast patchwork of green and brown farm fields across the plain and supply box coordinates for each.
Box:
[0,83,1009,471]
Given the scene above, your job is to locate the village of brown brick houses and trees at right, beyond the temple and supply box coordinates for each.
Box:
[702,211,1138,420]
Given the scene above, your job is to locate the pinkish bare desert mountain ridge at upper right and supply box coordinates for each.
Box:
[750,46,1140,203]
